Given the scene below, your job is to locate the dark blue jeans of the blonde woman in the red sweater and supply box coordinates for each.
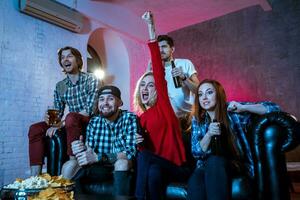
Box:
[135,150,192,200]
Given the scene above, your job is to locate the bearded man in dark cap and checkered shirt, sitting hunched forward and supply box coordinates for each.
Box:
[62,85,138,195]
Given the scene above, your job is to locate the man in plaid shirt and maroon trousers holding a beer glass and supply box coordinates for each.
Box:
[28,46,98,176]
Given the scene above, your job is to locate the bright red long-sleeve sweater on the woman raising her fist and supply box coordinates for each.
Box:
[140,42,186,165]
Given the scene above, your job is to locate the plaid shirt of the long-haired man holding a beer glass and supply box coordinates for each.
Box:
[54,72,98,117]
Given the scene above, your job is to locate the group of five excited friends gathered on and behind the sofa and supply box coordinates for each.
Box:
[28,11,280,200]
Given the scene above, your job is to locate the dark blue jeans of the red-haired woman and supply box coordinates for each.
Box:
[188,155,231,200]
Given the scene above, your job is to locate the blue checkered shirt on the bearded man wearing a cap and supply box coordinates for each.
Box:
[86,110,138,159]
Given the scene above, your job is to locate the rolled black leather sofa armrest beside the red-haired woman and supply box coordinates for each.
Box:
[252,112,299,199]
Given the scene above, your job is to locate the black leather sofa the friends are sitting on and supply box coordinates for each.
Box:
[47,112,300,200]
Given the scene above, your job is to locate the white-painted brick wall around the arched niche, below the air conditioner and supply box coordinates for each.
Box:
[0,0,148,187]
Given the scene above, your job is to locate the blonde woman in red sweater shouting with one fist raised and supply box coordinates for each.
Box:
[134,11,191,200]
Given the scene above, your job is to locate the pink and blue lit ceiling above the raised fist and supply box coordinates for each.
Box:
[61,0,271,40]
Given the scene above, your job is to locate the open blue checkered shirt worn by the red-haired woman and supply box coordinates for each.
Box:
[192,102,280,177]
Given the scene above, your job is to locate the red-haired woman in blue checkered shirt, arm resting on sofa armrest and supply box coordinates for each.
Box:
[188,79,279,200]
